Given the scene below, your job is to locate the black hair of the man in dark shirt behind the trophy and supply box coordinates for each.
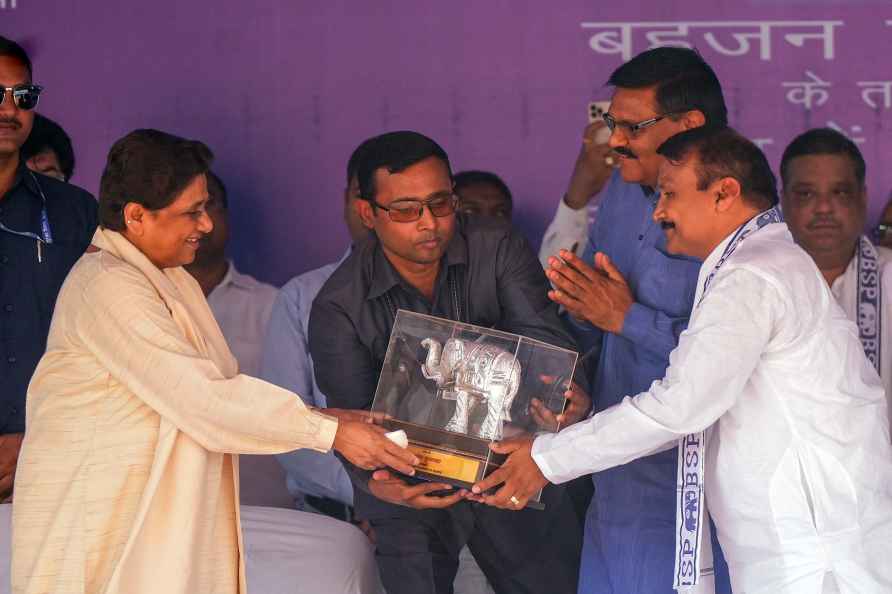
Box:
[356,130,452,200]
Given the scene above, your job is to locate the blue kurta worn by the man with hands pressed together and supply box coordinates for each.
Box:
[578,172,731,594]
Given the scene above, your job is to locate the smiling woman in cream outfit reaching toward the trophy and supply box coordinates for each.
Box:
[12,130,415,594]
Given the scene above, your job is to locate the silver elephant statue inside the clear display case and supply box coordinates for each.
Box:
[421,338,520,440]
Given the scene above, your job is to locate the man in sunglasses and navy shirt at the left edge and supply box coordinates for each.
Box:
[0,36,97,502]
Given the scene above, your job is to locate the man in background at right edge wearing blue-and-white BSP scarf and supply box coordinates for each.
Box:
[781,128,892,423]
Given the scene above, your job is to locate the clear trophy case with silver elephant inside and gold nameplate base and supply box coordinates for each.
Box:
[372,310,577,507]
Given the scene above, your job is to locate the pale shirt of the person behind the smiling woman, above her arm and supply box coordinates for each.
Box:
[208,262,279,377]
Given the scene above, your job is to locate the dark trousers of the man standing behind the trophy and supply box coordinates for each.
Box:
[371,494,582,594]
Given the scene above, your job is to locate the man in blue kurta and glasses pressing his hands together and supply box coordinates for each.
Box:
[540,47,730,594]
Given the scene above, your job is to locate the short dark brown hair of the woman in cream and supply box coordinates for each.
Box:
[99,130,214,231]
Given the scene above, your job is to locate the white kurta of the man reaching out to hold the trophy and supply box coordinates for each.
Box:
[533,223,892,594]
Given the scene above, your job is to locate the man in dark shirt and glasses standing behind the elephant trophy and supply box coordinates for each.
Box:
[309,132,589,594]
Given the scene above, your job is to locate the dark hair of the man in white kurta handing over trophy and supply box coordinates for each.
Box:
[657,126,778,209]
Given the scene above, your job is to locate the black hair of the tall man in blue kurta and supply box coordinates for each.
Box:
[607,47,728,126]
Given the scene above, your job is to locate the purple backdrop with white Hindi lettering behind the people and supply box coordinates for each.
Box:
[0,0,892,283]
